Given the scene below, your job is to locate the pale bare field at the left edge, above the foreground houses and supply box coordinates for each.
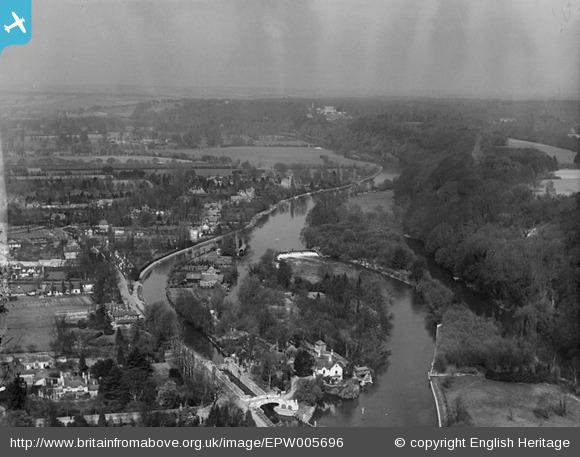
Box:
[5,296,93,352]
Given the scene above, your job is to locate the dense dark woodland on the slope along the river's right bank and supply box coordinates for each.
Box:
[395,134,580,377]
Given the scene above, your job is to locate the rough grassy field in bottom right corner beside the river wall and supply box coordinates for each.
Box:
[435,376,580,427]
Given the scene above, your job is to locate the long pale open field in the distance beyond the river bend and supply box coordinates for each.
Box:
[174,146,367,168]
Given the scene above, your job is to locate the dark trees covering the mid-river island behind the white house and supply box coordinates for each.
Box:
[216,251,391,368]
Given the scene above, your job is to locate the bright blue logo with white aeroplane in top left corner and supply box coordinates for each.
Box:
[0,0,32,54]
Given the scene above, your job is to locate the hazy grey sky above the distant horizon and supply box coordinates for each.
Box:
[0,0,580,97]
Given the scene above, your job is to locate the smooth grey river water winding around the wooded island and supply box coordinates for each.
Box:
[143,172,437,427]
